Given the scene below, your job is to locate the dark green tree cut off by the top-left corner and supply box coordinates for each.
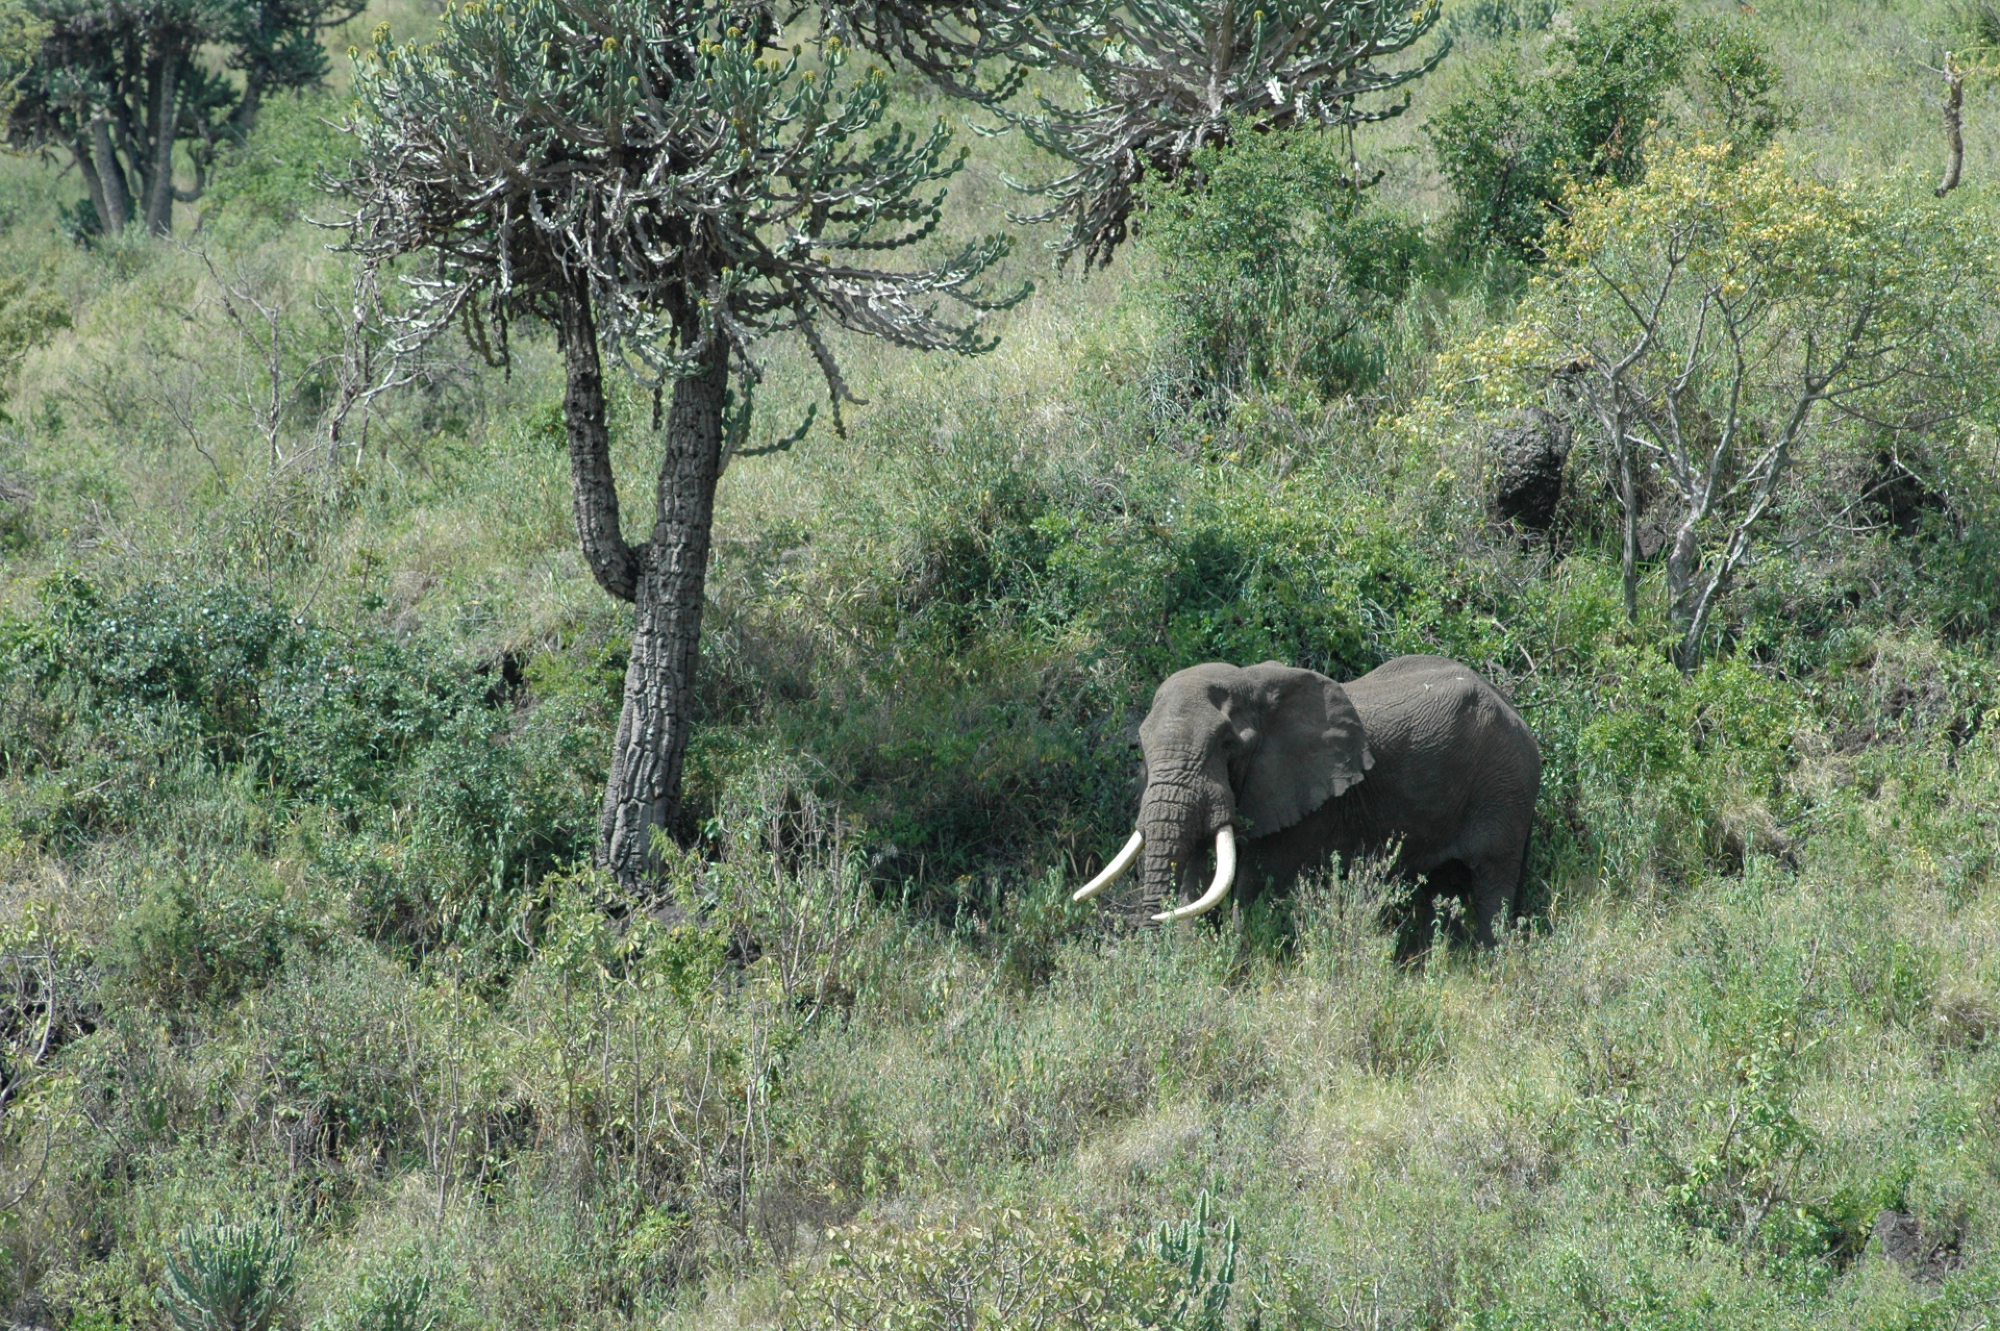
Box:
[0,0,366,234]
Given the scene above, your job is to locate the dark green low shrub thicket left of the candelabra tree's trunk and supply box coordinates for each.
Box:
[0,578,608,945]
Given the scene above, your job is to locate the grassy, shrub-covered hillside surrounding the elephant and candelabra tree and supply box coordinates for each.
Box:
[0,0,2000,1331]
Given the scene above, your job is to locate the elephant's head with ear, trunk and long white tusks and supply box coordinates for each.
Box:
[1076,662,1374,919]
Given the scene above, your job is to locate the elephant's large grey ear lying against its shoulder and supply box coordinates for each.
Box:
[1236,662,1374,837]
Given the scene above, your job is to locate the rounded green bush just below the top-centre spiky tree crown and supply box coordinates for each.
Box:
[1144,126,1424,396]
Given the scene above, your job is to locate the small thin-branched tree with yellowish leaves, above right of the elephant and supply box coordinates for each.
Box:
[1446,144,2000,669]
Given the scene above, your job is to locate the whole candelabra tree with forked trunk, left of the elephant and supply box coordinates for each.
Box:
[346,0,1006,887]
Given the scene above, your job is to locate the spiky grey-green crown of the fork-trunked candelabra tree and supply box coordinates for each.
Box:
[348,0,1020,416]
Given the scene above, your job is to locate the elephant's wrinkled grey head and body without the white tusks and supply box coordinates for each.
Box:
[1138,656,1542,943]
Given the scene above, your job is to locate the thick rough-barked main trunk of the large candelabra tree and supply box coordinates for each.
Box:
[596,331,728,887]
